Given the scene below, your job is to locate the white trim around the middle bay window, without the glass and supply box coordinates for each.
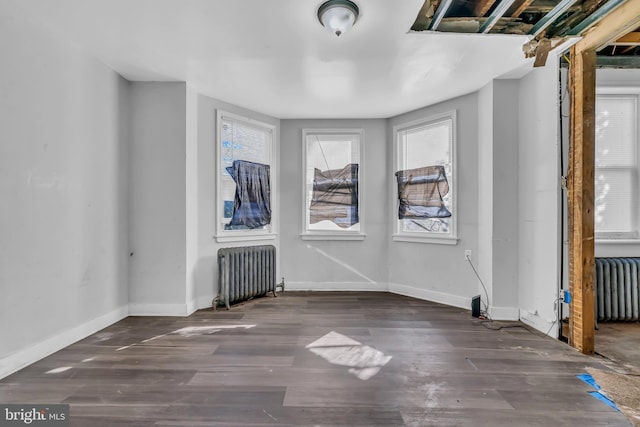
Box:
[300,128,367,240]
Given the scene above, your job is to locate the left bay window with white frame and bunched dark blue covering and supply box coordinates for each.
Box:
[216,110,276,241]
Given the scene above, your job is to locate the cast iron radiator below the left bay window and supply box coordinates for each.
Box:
[213,245,276,310]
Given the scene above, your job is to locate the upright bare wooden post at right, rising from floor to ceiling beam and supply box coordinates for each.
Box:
[567,45,596,354]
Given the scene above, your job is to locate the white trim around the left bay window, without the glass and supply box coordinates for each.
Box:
[214,109,278,243]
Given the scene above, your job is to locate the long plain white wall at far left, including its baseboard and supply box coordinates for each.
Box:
[0,2,129,378]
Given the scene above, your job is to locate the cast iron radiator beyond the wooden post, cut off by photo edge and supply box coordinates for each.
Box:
[595,258,640,322]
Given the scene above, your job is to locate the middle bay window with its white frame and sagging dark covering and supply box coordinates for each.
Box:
[302,129,364,240]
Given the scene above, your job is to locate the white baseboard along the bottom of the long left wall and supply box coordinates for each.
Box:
[0,306,129,379]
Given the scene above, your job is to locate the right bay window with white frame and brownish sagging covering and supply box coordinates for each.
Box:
[393,112,457,244]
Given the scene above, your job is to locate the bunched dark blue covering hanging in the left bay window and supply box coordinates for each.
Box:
[225,160,271,230]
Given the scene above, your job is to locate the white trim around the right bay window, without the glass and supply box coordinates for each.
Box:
[390,110,459,245]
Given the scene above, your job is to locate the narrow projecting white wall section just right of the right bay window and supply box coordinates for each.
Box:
[474,80,519,320]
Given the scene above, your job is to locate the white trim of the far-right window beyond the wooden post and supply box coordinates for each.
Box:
[594,86,640,245]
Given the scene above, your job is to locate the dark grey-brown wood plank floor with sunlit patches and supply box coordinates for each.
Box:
[0,292,629,427]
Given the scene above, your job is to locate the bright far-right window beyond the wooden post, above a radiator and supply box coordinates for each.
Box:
[594,93,638,240]
